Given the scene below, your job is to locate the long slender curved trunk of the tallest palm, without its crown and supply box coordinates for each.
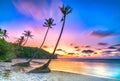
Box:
[42,16,66,68]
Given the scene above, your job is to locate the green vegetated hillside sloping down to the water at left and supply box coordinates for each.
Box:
[0,36,53,61]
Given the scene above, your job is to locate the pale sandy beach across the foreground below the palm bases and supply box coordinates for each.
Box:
[0,62,120,81]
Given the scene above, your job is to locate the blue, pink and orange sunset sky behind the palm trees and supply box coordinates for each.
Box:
[0,0,120,58]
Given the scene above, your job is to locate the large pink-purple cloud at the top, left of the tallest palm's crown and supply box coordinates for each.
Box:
[13,0,61,20]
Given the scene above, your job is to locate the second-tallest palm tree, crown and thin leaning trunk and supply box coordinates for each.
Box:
[28,18,56,63]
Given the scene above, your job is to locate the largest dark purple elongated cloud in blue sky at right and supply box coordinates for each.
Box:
[90,30,120,38]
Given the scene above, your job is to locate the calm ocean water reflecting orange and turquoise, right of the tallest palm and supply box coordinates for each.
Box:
[50,59,120,79]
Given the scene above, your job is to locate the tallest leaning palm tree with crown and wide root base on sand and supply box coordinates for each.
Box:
[30,5,72,72]
